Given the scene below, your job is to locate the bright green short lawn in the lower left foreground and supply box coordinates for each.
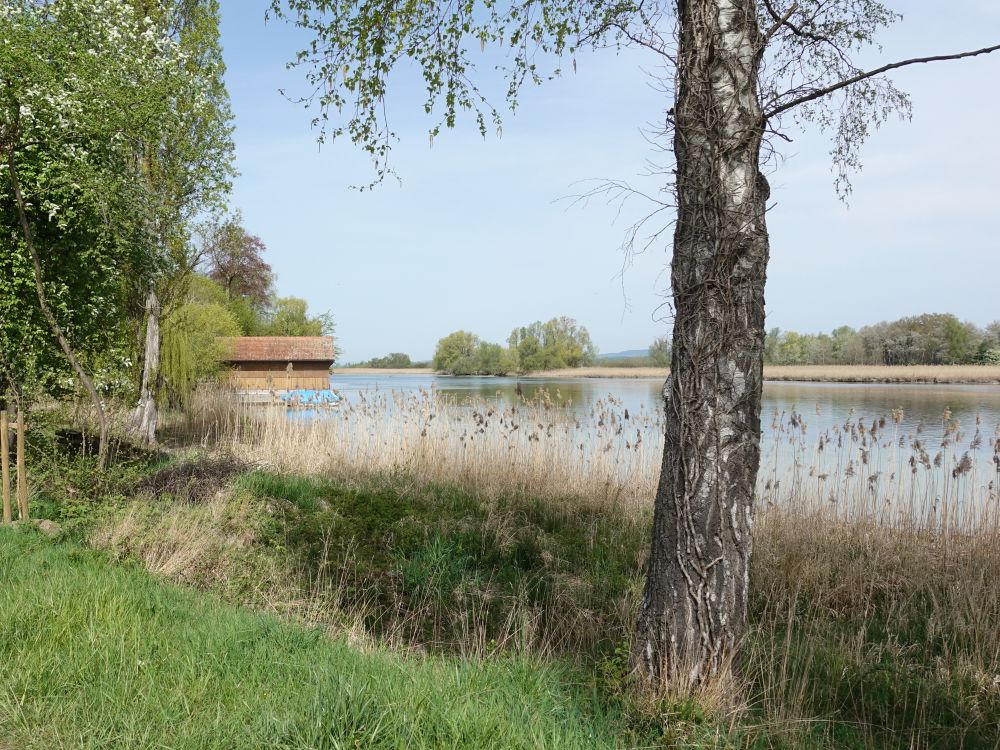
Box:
[0,529,640,749]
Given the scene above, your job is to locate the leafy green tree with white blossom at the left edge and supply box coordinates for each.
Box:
[0,0,225,464]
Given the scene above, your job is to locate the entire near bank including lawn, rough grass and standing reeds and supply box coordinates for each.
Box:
[9,392,1000,749]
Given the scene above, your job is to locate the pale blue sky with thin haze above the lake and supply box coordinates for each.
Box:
[222,0,1000,362]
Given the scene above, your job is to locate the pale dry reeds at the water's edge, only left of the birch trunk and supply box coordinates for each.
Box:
[186,389,660,504]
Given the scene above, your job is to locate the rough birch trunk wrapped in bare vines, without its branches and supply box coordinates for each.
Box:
[632,0,768,693]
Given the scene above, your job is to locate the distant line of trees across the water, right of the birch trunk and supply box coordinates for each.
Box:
[764,313,1000,365]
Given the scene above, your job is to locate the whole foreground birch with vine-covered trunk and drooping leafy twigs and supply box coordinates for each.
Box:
[272,0,1000,691]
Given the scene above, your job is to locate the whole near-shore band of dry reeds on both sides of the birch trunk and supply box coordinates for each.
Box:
[184,388,1000,531]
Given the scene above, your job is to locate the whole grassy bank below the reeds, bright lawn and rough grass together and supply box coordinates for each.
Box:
[19,434,1000,748]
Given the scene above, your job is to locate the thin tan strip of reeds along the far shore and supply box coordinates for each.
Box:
[333,365,1000,385]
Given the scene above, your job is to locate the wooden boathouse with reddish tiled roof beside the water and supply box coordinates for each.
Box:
[219,336,336,391]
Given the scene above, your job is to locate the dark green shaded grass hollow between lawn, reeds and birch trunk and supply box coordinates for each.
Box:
[234,471,646,660]
